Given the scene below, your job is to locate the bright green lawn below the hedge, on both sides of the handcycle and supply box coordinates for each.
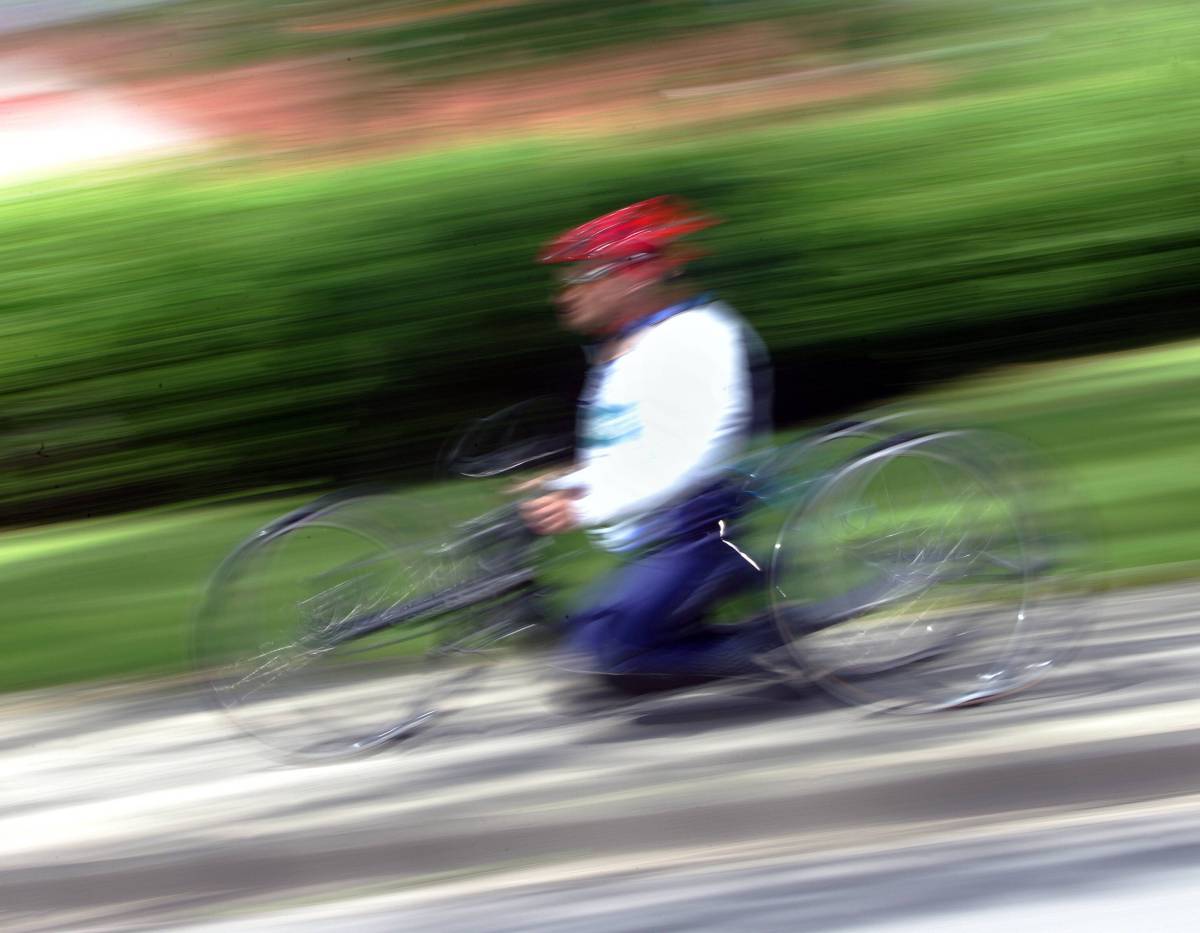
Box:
[0,342,1200,690]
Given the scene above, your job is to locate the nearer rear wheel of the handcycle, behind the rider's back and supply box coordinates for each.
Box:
[772,432,1084,711]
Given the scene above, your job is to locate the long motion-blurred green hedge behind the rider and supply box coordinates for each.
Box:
[0,0,1200,522]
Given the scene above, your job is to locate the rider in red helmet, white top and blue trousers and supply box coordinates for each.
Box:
[522,197,779,682]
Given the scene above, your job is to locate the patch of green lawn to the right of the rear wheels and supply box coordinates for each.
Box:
[916,342,1200,582]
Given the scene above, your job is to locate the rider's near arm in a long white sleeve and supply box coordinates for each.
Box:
[560,318,750,526]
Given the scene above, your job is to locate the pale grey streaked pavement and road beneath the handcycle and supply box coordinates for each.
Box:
[0,588,1200,933]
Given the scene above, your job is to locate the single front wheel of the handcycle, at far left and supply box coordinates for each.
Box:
[196,496,501,760]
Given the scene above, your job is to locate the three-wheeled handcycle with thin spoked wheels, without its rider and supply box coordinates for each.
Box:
[196,407,1088,760]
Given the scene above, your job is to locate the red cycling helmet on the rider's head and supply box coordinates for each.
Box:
[539,195,718,265]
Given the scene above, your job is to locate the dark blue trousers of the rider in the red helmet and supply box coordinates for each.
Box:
[568,487,769,676]
